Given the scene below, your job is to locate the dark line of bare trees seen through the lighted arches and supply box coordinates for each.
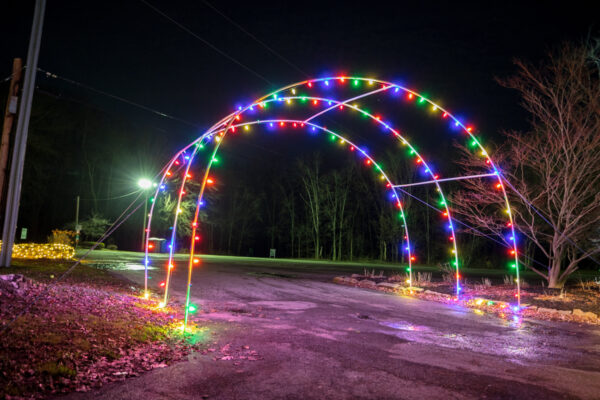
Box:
[191,153,460,263]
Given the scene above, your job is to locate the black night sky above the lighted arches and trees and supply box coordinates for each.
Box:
[0,0,599,248]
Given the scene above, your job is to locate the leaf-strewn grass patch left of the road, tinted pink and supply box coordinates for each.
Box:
[0,270,210,398]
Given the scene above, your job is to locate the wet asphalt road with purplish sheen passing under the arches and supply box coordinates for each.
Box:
[63,253,600,400]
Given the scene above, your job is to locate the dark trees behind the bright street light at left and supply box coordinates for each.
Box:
[0,87,178,247]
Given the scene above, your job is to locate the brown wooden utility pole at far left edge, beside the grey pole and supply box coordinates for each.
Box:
[0,58,23,204]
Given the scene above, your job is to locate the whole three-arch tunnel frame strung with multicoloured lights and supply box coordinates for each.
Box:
[144,77,520,328]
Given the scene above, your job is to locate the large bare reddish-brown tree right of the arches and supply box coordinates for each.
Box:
[452,44,600,288]
